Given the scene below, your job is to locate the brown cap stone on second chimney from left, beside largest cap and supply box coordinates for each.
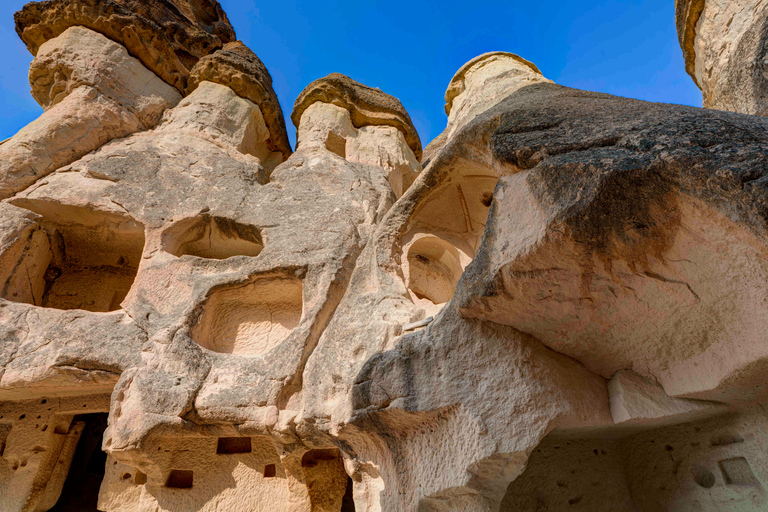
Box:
[187,41,291,158]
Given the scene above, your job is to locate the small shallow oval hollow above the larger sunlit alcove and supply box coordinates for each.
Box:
[163,215,264,260]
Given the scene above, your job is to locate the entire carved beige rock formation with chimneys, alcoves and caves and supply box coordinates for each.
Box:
[0,0,768,512]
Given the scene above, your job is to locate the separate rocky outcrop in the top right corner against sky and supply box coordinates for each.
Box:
[675,0,768,116]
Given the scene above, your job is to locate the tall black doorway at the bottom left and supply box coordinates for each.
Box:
[49,414,108,512]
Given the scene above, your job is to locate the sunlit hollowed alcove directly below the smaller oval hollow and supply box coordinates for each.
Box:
[191,277,303,356]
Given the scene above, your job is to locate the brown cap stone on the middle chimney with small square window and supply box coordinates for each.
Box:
[291,73,421,159]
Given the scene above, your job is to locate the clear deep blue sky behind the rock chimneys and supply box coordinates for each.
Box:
[0,0,701,150]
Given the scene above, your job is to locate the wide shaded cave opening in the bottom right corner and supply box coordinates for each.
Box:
[500,417,768,512]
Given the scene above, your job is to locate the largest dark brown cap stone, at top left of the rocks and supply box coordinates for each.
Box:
[14,0,236,92]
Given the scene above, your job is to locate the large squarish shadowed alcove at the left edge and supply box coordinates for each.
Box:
[0,201,144,312]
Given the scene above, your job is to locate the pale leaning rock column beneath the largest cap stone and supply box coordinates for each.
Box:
[0,27,181,198]
